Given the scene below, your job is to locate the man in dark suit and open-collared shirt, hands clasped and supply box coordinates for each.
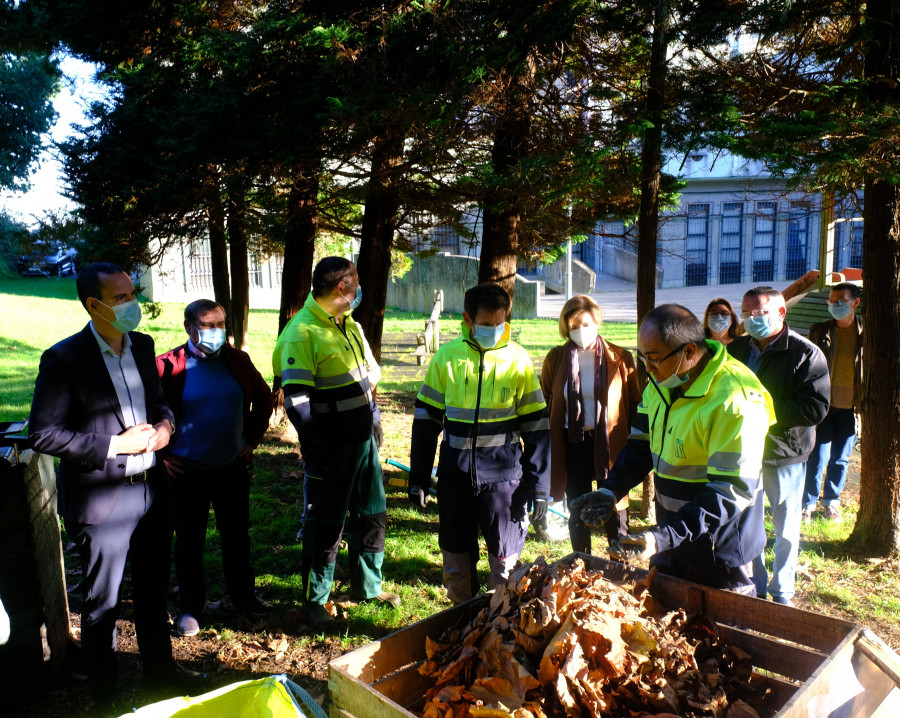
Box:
[30,263,199,708]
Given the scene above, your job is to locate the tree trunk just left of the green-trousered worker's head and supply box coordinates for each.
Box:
[278,163,319,334]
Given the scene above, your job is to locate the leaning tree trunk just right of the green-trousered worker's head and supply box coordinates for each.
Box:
[353,130,403,361]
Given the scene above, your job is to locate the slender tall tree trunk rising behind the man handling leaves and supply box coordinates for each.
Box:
[636,1,669,522]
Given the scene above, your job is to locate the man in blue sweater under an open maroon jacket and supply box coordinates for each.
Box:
[156,299,272,636]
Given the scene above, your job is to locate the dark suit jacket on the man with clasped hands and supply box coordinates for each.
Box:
[29,324,174,524]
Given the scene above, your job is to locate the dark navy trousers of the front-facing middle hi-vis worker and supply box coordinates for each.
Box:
[437,470,528,596]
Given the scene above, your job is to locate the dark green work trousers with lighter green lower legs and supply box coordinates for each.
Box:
[302,438,387,604]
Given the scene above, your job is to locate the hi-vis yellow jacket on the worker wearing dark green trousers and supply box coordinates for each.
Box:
[272,293,381,476]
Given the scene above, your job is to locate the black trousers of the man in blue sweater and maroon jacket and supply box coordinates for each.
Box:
[171,458,255,616]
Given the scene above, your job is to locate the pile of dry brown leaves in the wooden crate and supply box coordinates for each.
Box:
[419,559,764,718]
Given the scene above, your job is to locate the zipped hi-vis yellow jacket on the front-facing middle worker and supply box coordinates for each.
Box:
[409,322,550,499]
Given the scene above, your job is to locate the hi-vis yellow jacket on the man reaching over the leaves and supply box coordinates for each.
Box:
[603,341,775,567]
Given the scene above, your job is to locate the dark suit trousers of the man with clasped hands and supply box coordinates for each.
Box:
[66,478,172,695]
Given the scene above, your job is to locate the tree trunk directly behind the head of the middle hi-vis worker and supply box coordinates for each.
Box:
[478,87,531,312]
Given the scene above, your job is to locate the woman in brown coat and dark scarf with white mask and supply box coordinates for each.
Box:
[541,294,641,553]
